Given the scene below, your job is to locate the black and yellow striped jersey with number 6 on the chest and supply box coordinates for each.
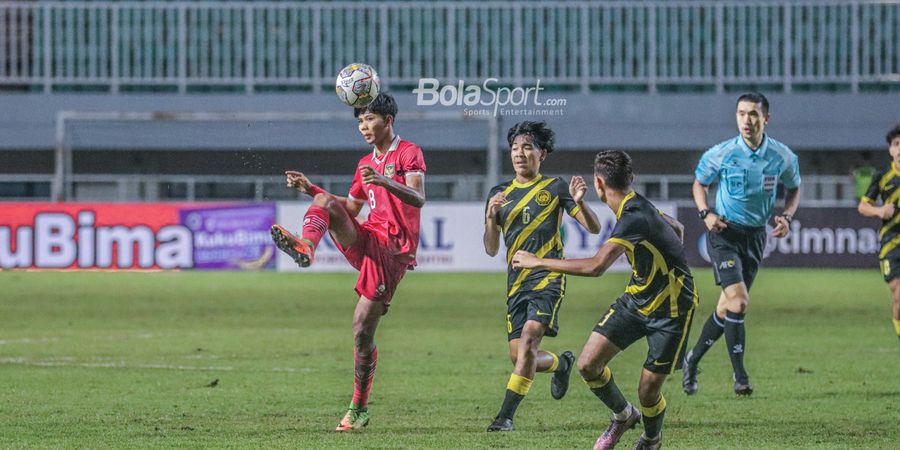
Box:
[488,174,581,297]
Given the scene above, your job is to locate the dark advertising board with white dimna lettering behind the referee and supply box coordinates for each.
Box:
[678,205,881,270]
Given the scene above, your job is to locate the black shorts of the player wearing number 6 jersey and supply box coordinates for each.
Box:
[506,286,563,341]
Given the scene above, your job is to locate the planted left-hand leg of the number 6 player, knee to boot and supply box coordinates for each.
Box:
[487,320,552,431]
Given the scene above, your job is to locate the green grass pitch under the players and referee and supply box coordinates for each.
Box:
[0,269,900,449]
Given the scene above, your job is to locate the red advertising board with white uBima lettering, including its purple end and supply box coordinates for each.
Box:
[0,203,275,270]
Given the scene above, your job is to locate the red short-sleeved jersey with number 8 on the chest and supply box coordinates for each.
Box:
[350,136,425,265]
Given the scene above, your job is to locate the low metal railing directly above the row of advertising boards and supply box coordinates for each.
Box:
[0,174,857,207]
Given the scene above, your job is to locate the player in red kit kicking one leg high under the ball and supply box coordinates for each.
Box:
[272,94,425,431]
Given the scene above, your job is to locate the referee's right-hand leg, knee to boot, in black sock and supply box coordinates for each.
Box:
[716,282,753,395]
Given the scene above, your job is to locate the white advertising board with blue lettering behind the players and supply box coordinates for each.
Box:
[276,202,677,272]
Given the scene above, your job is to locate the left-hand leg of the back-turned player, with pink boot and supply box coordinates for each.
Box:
[578,331,641,450]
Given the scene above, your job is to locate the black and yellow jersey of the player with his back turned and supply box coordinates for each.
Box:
[608,192,699,317]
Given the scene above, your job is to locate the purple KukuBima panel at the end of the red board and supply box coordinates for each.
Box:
[179,203,275,270]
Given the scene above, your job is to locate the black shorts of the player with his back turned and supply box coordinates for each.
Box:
[594,298,694,374]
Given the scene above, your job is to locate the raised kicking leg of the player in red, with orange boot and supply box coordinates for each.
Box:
[272,193,356,267]
